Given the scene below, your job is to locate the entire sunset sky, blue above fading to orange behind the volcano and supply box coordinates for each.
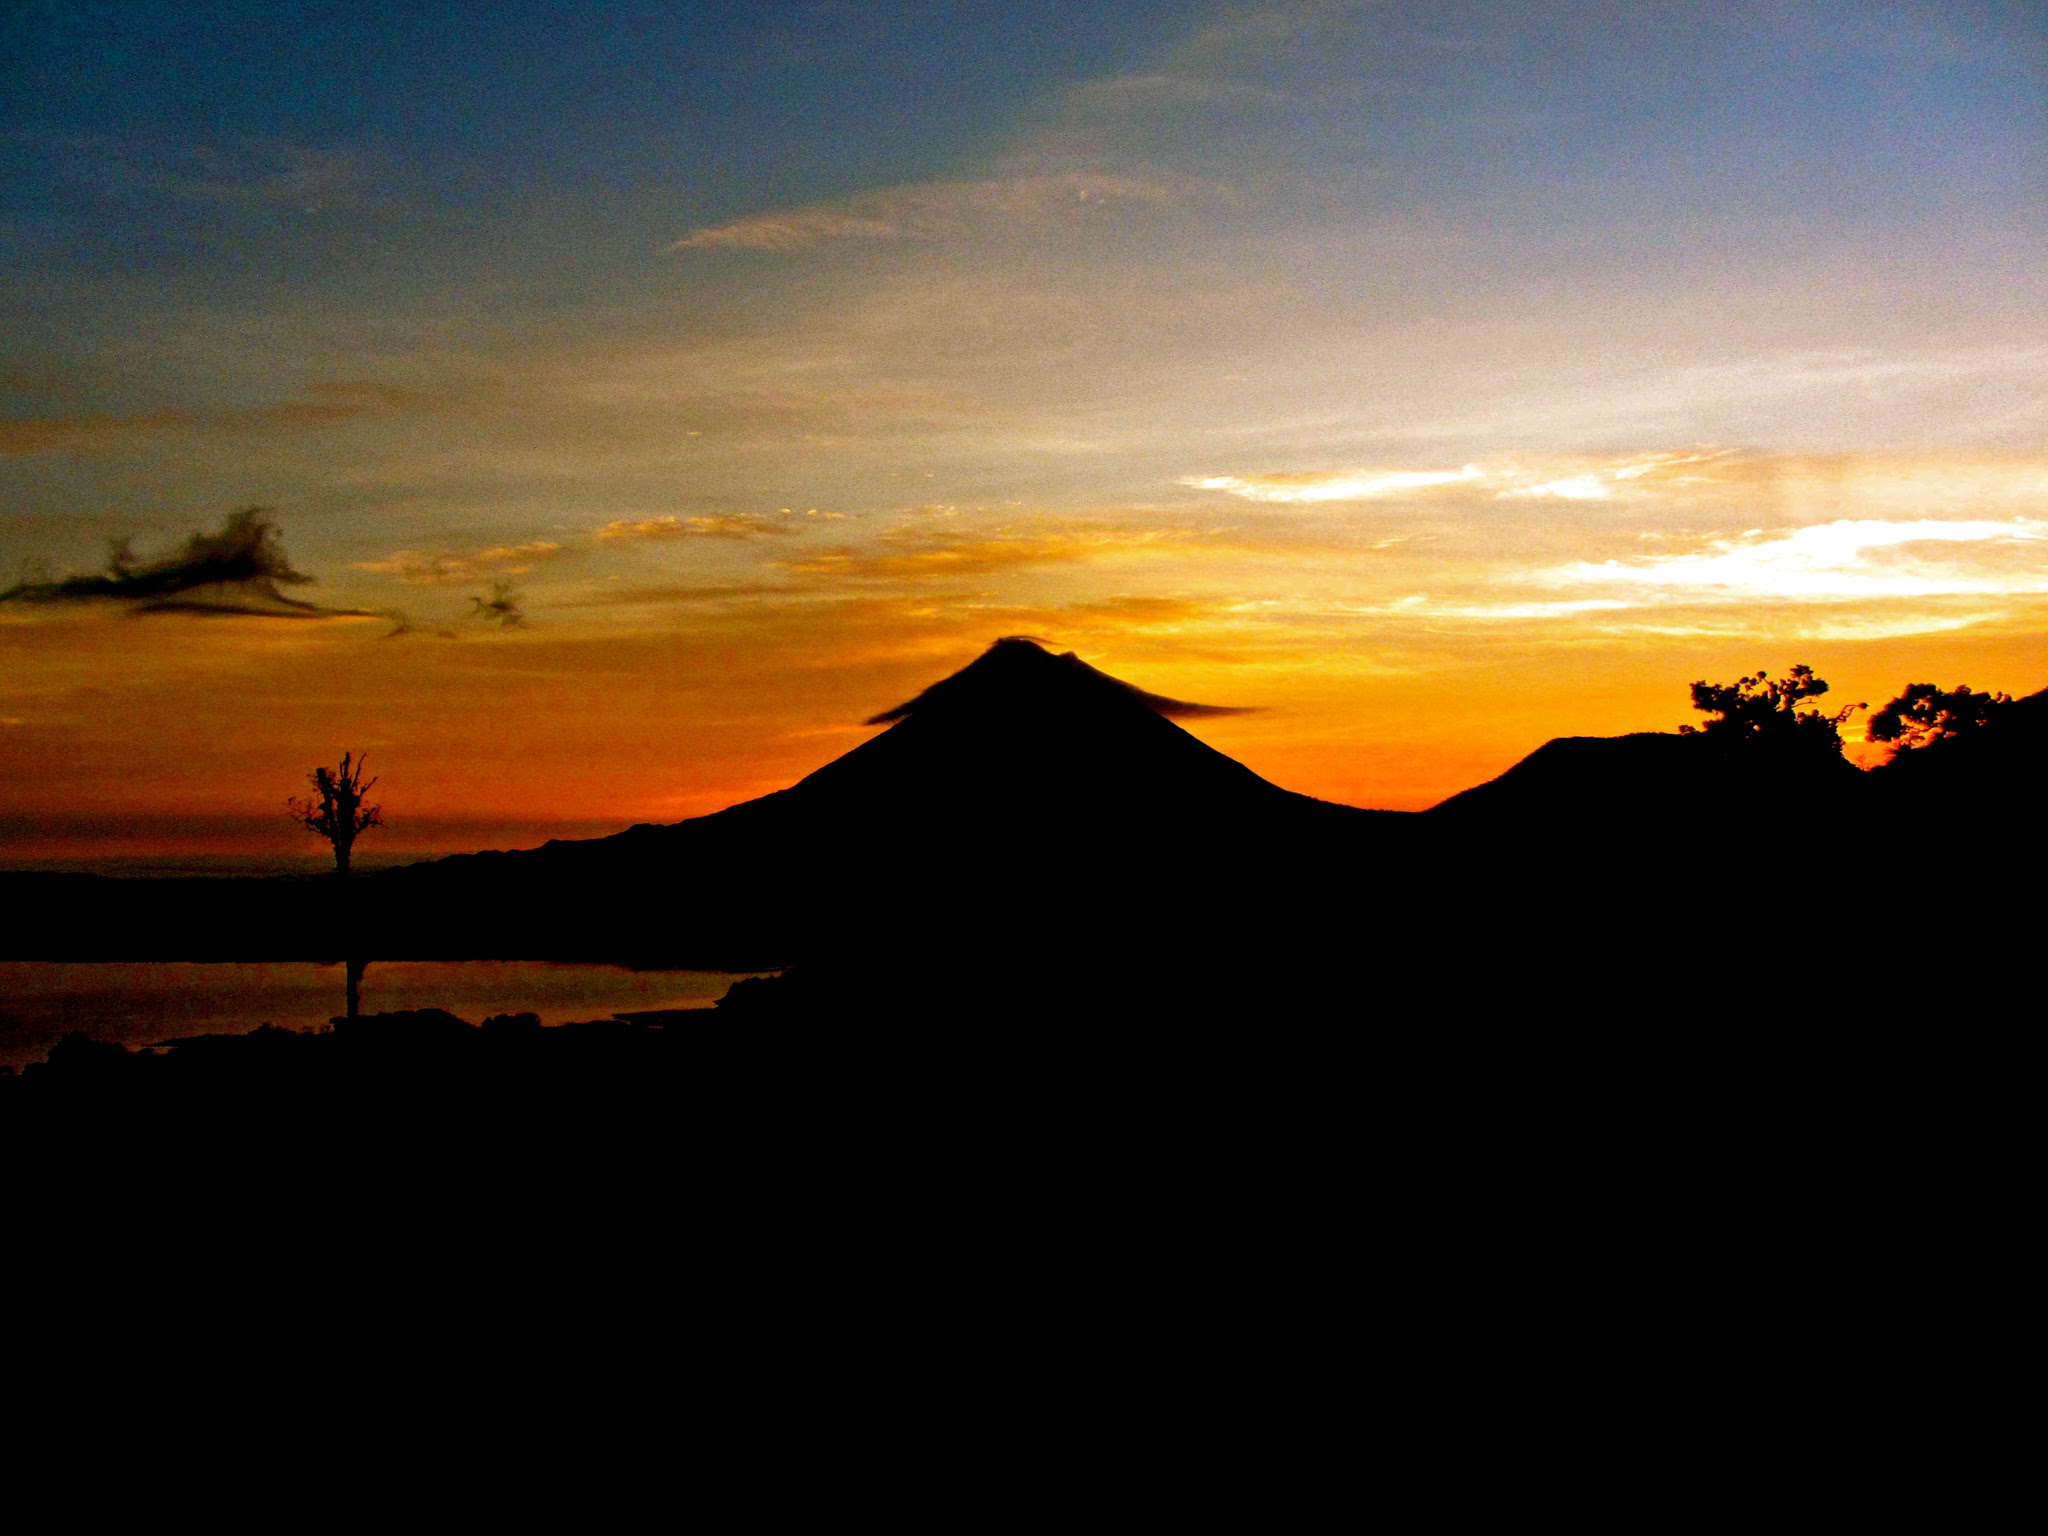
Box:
[0,0,2048,864]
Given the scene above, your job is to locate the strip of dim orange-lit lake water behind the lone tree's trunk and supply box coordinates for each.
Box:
[0,961,770,1069]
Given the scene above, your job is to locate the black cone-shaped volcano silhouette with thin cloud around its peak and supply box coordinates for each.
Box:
[369,639,1399,965]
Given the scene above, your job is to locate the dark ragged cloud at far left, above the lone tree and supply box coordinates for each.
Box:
[0,506,365,618]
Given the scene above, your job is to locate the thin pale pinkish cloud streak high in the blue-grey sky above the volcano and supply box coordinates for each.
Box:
[670,172,1171,252]
